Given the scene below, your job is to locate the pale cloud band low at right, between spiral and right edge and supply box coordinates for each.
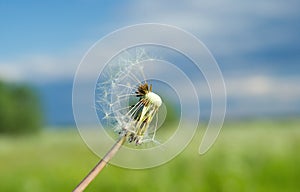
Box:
[226,74,300,117]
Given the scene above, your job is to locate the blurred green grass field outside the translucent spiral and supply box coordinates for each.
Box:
[0,120,300,192]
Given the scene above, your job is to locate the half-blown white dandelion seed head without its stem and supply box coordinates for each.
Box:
[96,49,162,144]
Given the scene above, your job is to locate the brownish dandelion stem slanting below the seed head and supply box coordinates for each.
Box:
[73,134,127,192]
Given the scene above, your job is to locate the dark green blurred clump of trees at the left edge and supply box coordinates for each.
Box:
[0,81,43,134]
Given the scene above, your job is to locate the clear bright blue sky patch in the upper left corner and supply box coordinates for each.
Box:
[0,1,125,58]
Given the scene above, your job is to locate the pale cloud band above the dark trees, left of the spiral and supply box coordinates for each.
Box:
[0,48,83,82]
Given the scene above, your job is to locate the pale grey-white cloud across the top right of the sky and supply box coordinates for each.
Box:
[127,0,298,56]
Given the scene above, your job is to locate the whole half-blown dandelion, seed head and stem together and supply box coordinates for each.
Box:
[74,51,162,192]
